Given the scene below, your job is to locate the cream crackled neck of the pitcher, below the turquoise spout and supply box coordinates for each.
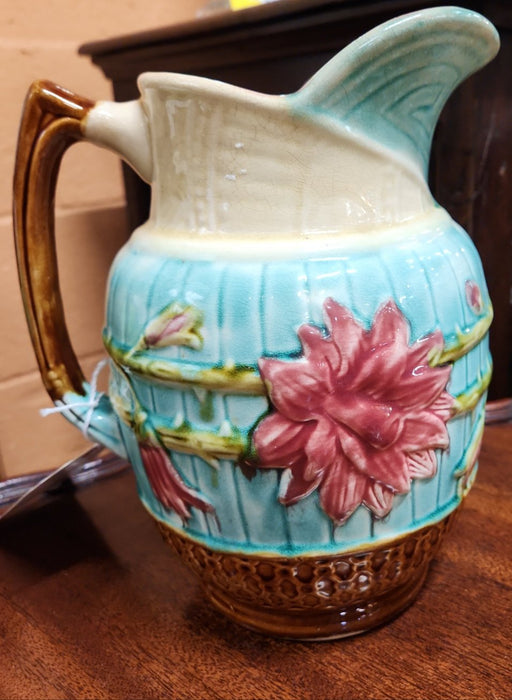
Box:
[143,79,434,235]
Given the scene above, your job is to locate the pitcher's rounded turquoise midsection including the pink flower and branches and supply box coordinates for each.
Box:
[105,208,491,552]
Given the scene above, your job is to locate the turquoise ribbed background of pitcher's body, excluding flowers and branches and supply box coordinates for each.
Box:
[99,211,491,554]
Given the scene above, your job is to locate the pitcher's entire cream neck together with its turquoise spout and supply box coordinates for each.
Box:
[87,7,499,238]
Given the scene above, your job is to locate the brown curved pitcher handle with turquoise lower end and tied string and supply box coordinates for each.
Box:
[13,81,126,457]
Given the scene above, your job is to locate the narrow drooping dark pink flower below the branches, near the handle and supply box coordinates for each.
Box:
[139,442,214,522]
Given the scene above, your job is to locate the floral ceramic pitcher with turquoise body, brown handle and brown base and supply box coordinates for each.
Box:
[15,7,498,639]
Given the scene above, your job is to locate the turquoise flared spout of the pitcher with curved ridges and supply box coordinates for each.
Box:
[289,7,499,176]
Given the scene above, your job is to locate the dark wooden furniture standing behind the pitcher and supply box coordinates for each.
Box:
[81,0,512,404]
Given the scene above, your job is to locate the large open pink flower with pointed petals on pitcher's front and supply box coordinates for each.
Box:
[254,299,453,525]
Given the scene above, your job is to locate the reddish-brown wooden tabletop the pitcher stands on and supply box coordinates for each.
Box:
[0,424,512,700]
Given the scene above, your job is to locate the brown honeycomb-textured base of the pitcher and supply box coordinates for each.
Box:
[158,511,457,640]
